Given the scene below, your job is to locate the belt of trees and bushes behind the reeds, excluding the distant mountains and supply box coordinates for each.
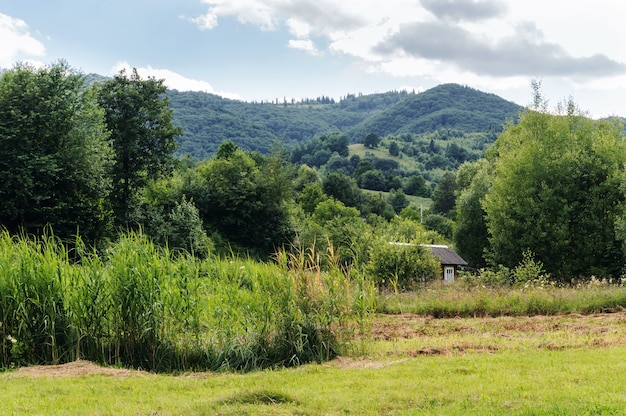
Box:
[0,62,626,281]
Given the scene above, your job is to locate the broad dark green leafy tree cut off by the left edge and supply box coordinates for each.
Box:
[0,62,113,242]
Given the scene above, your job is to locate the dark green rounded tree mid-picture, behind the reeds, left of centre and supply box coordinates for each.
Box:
[188,144,293,256]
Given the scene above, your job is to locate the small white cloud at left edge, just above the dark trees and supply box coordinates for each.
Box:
[0,13,46,67]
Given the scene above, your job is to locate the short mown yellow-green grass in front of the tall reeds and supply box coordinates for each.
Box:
[0,312,626,415]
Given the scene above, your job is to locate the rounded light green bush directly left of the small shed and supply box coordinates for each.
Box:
[368,243,441,291]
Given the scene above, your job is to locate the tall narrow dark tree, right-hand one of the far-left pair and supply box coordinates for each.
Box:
[98,69,182,227]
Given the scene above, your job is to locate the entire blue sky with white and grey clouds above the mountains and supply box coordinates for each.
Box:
[0,0,626,117]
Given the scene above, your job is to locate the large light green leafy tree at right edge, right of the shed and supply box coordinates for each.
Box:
[483,95,626,280]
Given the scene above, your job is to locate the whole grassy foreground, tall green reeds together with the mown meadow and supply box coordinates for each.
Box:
[0,232,626,415]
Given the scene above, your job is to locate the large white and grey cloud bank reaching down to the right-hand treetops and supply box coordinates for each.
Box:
[185,0,626,113]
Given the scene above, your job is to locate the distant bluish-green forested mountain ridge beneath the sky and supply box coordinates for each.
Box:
[168,84,521,159]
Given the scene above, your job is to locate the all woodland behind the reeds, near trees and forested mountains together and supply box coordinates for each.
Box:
[0,62,625,281]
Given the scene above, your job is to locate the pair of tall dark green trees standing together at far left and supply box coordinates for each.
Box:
[0,62,180,241]
